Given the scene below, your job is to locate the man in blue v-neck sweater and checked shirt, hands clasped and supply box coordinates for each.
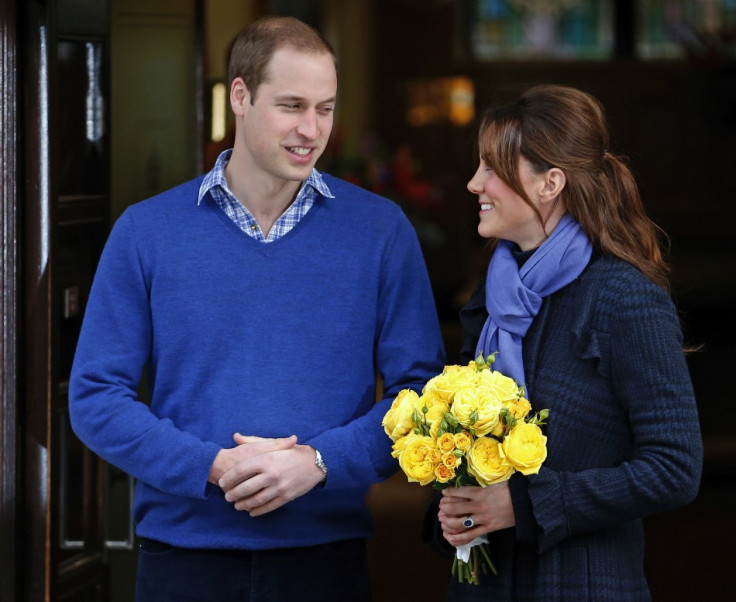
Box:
[70,17,444,602]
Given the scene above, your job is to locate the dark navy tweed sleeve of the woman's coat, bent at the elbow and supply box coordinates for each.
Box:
[528,278,703,551]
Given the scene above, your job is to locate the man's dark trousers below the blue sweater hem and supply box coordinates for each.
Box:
[135,539,371,602]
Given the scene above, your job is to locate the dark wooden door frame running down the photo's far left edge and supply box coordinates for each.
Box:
[0,0,55,602]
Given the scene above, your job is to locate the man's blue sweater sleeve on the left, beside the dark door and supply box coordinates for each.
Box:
[69,211,220,498]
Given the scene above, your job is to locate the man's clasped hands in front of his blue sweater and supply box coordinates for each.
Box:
[208,433,324,517]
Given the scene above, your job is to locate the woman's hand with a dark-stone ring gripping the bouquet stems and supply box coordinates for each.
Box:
[439,481,516,547]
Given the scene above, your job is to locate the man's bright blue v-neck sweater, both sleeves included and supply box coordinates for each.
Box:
[69,176,444,549]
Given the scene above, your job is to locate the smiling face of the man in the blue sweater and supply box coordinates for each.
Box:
[236,47,337,182]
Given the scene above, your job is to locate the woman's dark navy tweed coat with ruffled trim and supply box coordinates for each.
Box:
[423,257,702,602]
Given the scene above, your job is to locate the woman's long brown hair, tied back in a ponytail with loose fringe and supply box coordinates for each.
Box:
[478,85,669,290]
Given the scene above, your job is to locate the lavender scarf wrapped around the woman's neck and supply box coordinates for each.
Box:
[476,214,593,385]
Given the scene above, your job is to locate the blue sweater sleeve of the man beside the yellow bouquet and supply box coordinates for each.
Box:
[307,213,445,488]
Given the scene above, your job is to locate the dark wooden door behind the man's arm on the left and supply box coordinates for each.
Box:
[19,0,110,602]
